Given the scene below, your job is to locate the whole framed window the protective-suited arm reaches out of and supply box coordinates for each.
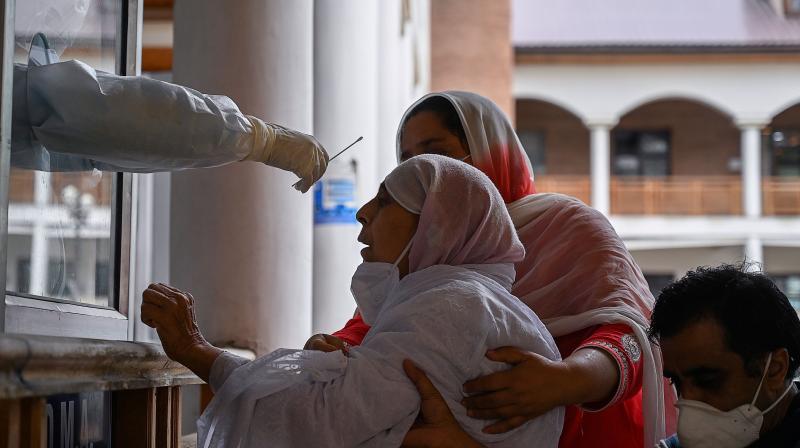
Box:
[0,0,138,339]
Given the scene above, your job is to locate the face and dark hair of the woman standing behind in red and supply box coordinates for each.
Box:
[400,111,472,164]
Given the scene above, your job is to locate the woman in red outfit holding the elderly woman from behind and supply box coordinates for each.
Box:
[309,92,674,447]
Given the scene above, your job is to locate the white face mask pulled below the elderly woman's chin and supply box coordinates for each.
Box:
[350,237,414,325]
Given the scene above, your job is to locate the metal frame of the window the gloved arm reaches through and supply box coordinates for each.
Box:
[0,0,142,340]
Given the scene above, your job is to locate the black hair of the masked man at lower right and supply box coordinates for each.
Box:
[648,264,800,378]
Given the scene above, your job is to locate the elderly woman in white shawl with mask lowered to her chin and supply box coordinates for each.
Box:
[142,155,563,447]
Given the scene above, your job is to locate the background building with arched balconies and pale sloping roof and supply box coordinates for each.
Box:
[512,0,800,305]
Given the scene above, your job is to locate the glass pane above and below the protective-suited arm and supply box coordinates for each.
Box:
[6,0,120,306]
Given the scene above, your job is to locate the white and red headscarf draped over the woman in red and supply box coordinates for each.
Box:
[397,91,671,447]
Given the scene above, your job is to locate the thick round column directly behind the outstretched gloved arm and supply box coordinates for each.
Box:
[170,0,313,354]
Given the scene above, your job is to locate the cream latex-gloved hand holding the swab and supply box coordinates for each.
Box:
[244,115,328,193]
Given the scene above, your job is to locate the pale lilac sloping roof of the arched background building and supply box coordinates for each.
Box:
[512,0,800,51]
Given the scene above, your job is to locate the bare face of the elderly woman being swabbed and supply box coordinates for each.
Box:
[356,185,419,275]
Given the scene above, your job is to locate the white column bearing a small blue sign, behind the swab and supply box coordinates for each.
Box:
[313,0,382,333]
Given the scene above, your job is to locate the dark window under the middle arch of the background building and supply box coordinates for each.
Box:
[611,130,670,176]
